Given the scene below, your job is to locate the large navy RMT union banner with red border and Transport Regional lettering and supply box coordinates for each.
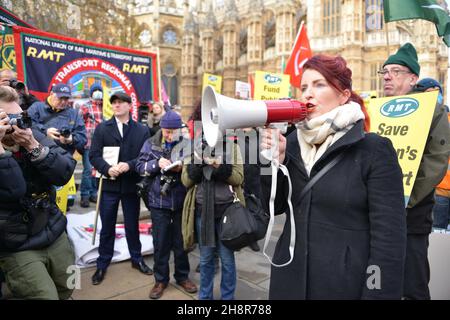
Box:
[13,26,159,120]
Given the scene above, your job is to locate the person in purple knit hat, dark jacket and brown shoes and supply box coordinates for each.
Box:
[136,111,197,299]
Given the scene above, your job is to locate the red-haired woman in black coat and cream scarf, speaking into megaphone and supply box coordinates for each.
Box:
[261,55,406,299]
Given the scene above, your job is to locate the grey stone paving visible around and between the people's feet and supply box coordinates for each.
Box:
[66,199,281,300]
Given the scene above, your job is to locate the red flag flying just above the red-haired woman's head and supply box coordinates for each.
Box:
[284,22,312,88]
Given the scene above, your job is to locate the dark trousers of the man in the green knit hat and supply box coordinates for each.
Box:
[403,234,430,300]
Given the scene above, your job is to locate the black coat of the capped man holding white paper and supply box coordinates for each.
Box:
[89,117,149,194]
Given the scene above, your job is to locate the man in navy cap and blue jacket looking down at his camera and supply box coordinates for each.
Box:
[28,83,87,154]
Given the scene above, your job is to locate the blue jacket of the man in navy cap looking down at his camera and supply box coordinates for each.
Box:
[28,101,87,154]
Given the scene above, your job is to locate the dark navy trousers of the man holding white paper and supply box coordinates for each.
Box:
[97,192,142,269]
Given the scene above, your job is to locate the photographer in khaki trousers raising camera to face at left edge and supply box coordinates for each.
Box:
[0,86,76,300]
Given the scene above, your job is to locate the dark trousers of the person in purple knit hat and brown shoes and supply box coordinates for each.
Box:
[150,208,189,283]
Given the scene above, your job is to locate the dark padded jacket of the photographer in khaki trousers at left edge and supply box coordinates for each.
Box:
[0,130,76,252]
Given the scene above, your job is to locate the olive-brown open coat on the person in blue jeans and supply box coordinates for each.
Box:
[181,143,245,250]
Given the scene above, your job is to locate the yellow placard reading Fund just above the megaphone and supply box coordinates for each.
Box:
[254,71,290,100]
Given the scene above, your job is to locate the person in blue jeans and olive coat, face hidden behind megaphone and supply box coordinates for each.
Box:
[182,130,245,300]
